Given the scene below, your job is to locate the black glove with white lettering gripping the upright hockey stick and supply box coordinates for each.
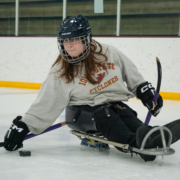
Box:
[137,82,163,116]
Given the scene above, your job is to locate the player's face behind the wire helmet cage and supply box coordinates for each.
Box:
[63,38,85,57]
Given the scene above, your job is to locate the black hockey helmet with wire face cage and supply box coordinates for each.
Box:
[58,15,92,64]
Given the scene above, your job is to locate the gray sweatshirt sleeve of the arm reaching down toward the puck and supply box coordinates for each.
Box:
[22,65,69,134]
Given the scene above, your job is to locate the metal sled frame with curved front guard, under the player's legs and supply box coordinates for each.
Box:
[70,126,175,156]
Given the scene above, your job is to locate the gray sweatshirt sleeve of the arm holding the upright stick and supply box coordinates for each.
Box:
[113,46,145,96]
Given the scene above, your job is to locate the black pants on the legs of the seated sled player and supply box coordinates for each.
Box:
[95,102,180,148]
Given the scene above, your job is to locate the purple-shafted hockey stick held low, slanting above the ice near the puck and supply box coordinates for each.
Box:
[0,121,66,147]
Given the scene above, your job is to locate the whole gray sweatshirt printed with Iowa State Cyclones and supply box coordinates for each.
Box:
[22,44,145,134]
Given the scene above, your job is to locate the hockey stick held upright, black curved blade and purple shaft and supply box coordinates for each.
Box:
[145,57,162,125]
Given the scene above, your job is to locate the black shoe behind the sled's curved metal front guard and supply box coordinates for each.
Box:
[136,126,156,162]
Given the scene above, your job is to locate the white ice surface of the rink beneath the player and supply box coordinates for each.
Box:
[0,88,180,180]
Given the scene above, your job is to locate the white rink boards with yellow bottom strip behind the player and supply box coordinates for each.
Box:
[0,37,180,100]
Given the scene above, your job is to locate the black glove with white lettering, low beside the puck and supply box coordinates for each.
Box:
[4,116,29,151]
